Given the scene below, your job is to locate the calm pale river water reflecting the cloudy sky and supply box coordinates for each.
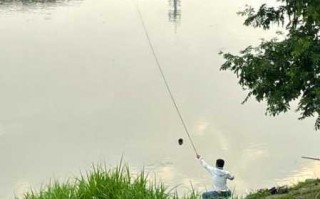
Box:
[0,0,320,199]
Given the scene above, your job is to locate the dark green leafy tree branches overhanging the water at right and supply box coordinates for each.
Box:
[221,0,320,129]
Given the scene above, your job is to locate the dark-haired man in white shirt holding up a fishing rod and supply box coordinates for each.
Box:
[197,154,234,199]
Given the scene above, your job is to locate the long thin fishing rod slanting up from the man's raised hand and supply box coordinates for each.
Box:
[136,1,198,154]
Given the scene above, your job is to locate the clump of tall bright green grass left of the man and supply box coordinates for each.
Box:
[20,164,199,199]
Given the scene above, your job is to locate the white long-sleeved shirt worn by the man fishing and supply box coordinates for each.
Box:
[200,158,234,191]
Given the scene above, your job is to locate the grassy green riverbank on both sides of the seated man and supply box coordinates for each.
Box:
[22,163,320,199]
